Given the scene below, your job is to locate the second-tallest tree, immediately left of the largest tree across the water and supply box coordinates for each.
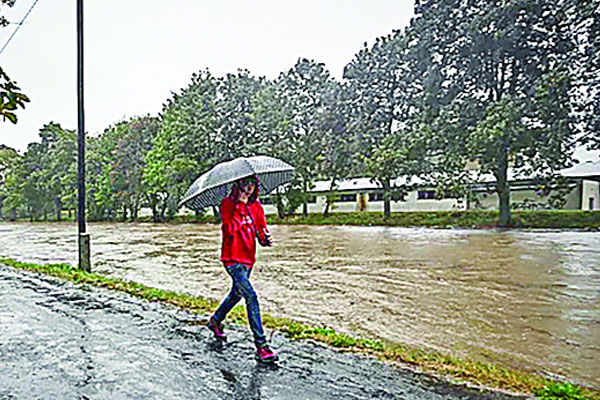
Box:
[344,32,426,218]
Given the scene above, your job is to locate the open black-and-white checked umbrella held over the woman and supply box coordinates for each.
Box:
[179,156,294,210]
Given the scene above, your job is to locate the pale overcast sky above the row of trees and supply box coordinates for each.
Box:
[0,0,598,160]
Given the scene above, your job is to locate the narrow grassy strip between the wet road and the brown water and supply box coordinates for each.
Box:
[0,258,600,399]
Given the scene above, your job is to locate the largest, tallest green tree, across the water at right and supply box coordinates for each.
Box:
[411,0,577,226]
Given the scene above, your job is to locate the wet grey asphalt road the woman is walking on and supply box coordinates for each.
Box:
[0,265,515,400]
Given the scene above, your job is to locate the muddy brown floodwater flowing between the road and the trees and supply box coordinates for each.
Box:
[0,223,600,388]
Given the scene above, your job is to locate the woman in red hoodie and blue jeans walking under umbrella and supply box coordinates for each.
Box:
[207,176,279,362]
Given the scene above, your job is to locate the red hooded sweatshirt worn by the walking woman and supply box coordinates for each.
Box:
[221,197,267,267]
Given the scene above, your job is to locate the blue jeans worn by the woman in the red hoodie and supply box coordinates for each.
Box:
[212,264,267,347]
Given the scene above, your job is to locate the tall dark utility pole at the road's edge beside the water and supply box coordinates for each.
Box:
[77,0,92,272]
